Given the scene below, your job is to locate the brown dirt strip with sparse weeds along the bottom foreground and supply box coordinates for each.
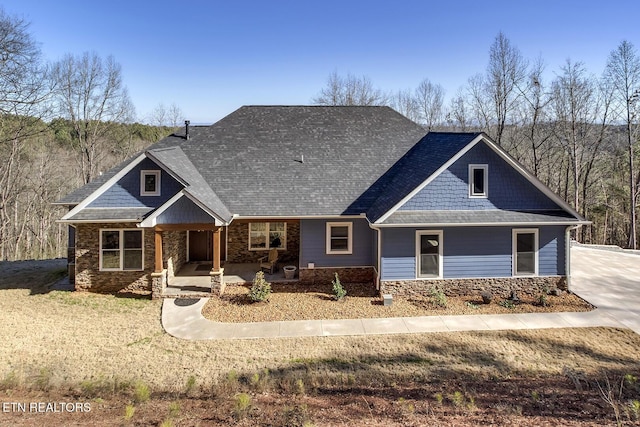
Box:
[0,376,637,427]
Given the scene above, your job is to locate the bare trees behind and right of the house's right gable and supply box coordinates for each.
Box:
[313,32,640,249]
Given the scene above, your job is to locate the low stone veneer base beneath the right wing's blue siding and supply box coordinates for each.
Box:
[380,276,567,298]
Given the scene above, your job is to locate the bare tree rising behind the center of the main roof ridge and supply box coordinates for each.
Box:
[312,71,389,105]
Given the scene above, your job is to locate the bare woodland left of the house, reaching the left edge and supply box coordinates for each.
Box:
[0,9,182,260]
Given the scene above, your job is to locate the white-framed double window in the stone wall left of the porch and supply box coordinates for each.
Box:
[100,229,144,271]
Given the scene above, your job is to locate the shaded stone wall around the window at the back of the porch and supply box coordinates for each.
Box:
[227,220,300,263]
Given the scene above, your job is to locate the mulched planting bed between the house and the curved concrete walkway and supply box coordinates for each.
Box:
[202,284,593,323]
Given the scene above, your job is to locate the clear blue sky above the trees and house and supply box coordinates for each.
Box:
[2,0,640,123]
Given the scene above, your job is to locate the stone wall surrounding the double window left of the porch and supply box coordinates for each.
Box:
[75,223,155,293]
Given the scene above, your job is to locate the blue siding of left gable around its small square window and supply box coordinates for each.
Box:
[88,159,183,208]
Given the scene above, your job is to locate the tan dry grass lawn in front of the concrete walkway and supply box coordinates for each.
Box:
[0,263,640,392]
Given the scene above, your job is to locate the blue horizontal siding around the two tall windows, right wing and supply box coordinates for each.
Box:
[381,226,565,280]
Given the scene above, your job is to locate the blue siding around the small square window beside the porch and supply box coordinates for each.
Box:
[300,218,376,267]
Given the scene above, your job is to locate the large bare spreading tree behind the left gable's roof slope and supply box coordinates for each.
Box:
[52,53,134,183]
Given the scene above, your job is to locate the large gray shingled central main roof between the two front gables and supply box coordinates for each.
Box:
[151,106,425,216]
